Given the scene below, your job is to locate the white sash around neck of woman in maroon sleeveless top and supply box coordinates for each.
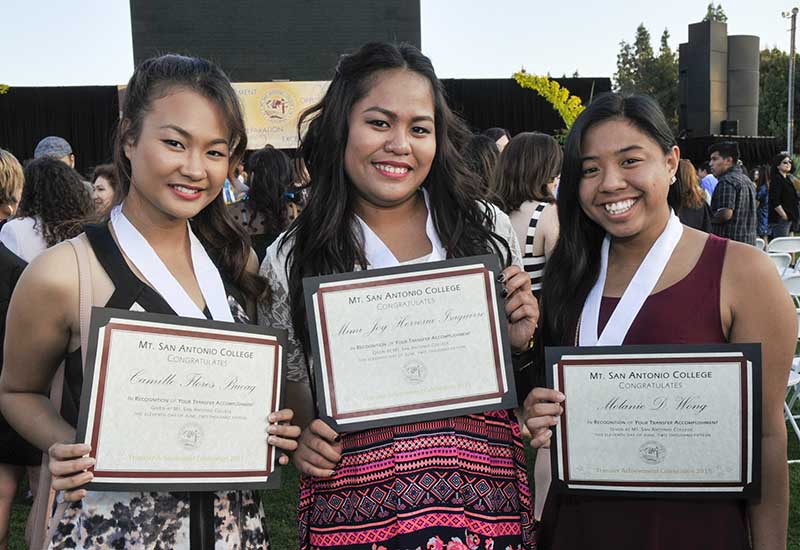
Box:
[578,213,683,346]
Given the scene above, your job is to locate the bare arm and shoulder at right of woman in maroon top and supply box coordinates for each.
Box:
[721,242,797,550]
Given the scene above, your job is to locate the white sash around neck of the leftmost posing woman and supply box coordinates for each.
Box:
[111,205,233,323]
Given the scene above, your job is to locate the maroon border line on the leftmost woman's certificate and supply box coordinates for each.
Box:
[89,322,280,483]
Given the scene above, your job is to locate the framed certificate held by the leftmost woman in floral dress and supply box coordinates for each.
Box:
[76,308,285,491]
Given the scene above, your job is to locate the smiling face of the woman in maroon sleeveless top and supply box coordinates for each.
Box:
[578,119,679,239]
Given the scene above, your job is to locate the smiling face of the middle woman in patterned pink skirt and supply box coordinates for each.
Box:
[344,69,436,212]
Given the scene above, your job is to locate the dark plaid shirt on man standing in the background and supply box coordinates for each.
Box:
[711,166,756,245]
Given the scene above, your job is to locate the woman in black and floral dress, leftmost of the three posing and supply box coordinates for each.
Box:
[0,55,300,550]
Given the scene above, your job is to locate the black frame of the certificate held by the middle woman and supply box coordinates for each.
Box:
[303,254,517,432]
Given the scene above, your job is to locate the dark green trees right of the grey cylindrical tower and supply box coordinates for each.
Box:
[758,48,800,150]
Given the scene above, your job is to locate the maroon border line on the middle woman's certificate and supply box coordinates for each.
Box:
[317,266,505,421]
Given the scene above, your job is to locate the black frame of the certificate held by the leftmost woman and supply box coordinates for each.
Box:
[75,307,287,492]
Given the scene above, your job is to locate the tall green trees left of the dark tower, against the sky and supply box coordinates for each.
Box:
[614,24,678,133]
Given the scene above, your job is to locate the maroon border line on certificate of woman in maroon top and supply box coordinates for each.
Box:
[556,355,750,487]
